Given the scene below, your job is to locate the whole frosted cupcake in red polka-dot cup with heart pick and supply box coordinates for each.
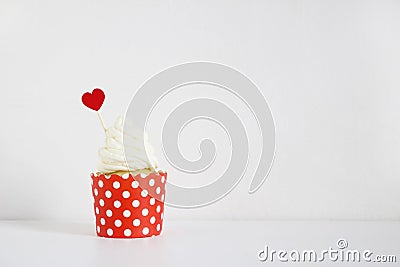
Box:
[82,89,167,238]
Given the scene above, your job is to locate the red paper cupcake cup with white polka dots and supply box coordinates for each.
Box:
[91,172,167,238]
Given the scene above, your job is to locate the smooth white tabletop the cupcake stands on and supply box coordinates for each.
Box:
[0,221,400,267]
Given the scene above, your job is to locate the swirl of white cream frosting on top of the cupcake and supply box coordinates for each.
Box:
[98,116,158,173]
